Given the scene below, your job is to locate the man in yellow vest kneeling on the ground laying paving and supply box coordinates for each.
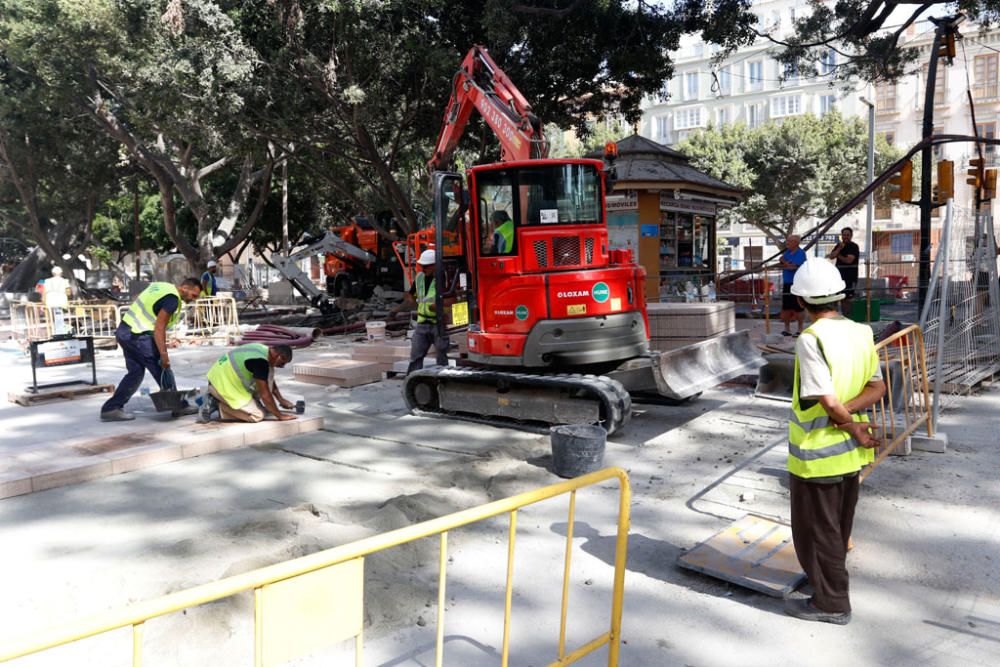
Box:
[201,343,295,423]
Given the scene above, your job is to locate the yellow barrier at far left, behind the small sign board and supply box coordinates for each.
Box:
[11,301,121,344]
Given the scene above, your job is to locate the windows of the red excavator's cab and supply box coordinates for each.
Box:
[476,163,601,255]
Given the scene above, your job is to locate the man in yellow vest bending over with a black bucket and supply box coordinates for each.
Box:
[101,278,201,421]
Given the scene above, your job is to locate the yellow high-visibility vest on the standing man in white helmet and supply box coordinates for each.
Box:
[788,317,878,479]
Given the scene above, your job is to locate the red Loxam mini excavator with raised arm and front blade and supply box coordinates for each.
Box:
[404,46,764,433]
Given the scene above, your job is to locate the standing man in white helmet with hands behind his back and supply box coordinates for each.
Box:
[785,258,885,625]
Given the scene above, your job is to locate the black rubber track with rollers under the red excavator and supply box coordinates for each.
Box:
[403,366,632,434]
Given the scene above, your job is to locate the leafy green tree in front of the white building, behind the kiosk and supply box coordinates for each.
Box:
[678,112,902,247]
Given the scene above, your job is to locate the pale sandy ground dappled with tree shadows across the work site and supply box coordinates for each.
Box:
[0,334,1000,666]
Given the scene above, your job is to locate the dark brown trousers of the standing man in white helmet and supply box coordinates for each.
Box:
[788,474,860,613]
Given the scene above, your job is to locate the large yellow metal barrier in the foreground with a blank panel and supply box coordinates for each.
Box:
[0,468,632,667]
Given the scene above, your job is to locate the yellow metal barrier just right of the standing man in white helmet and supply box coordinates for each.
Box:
[861,324,934,480]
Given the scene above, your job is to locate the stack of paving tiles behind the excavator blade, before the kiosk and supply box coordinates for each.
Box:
[647,301,736,352]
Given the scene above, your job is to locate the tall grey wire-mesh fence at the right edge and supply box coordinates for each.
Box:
[920,202,1000,411]
